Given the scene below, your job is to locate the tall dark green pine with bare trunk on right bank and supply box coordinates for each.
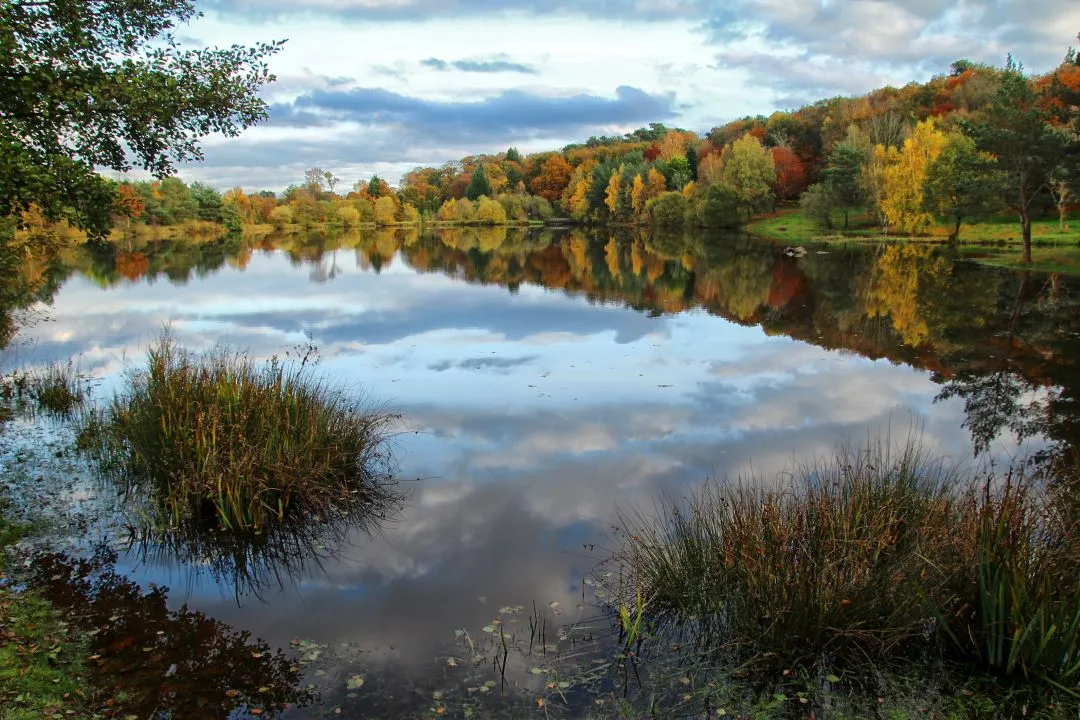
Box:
[967,57,1067,262]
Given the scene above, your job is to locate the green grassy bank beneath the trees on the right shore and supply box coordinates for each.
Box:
[746,208,1080,273]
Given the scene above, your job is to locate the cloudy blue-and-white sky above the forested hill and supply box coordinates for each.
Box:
[178,0,1080,190]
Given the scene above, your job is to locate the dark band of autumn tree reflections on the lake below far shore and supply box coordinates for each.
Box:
[10,227,1080,462]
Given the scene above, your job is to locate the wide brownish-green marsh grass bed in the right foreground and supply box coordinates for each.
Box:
[615,441,1080,693]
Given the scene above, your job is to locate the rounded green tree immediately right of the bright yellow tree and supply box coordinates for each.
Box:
[922,133,1001,243]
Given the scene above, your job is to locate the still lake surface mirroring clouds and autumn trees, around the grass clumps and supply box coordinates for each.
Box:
[2,230,1080,717]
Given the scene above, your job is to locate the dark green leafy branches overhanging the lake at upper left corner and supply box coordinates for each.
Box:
[0,0,282,236]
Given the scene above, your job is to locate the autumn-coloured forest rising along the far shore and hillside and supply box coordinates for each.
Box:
[42,43,1080,262]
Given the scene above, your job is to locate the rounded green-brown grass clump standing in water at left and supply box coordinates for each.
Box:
[81,336,395,530]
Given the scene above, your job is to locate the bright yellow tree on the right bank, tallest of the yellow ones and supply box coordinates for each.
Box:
[881,118,946,236]
